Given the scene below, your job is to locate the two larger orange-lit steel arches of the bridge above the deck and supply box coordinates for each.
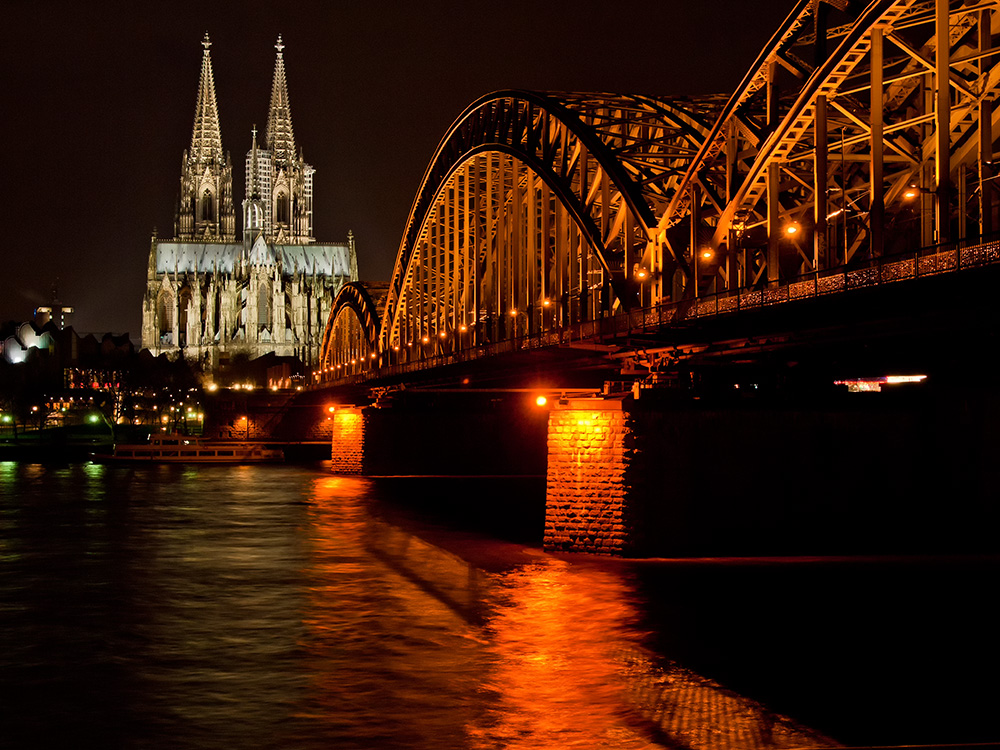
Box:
[323,0,1000,372]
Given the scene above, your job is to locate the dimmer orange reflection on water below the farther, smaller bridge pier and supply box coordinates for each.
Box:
[296,477,480,748]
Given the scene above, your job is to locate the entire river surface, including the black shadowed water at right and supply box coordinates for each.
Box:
[0,462,1000,750]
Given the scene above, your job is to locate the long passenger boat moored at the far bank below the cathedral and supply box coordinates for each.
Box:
[93,434,285,464]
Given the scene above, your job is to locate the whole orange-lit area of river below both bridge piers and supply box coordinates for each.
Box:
[289,477,836,750]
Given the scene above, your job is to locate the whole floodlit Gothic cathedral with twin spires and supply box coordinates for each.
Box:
[142,34,358,371]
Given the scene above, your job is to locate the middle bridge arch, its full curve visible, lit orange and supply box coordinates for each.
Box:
[380,91,722,361]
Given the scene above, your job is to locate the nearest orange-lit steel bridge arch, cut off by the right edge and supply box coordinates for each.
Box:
[657,0,1000,294]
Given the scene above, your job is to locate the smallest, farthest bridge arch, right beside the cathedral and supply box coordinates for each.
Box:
[319,281,379,377]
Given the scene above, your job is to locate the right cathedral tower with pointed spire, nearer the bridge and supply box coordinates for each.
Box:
[244,36,315,245]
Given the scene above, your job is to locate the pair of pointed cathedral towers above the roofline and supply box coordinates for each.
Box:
[174,32,314,244]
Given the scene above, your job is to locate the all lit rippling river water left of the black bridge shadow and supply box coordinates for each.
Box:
[0,464,992,750]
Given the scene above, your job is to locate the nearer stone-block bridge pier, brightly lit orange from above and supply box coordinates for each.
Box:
[544,399,631,555]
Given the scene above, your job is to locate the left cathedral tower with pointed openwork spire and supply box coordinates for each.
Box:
[174,32,236,242]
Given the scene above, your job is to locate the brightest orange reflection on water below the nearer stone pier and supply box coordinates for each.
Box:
[469,559,651,749]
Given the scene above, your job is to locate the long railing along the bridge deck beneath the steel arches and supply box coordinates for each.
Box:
[314,236,1000,386]
